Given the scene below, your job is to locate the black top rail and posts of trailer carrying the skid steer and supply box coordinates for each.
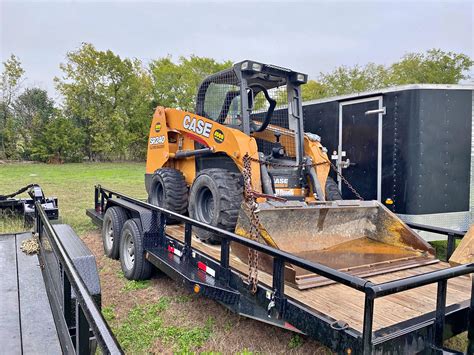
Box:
[95,185,474,354]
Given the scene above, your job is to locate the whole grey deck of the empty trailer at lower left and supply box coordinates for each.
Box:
[0,233,61,354]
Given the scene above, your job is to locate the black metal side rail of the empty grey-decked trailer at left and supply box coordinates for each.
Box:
[35,201,123,354]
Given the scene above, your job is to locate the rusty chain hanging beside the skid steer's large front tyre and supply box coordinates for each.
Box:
[243,154,260,294]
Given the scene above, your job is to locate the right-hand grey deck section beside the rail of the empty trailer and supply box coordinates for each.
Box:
[17,233,61,354]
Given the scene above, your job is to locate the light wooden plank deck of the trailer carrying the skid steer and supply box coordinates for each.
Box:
[166,225,471,331]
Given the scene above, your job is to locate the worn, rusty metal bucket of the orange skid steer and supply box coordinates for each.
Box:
[232,201,438,289]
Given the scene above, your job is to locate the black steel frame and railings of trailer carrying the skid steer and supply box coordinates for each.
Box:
[87,185,474,354]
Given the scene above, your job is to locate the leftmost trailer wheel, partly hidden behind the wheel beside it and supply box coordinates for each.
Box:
[102,206,128,259]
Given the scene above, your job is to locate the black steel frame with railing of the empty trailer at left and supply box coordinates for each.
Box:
[34,196,123,354]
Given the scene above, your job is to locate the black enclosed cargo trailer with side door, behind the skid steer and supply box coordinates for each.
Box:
[303,84,474,234]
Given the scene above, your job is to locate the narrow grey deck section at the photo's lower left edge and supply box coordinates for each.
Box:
[0,234,22,354]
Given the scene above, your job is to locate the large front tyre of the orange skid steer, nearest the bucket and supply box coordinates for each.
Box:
[189,169,243,244]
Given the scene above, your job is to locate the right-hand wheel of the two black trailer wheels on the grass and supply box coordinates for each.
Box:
[120,218,153,280]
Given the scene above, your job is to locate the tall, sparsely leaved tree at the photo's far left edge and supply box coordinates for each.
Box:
[0,54,25,159]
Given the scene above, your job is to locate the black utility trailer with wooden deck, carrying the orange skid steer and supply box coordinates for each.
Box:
[87,186,474,354]
